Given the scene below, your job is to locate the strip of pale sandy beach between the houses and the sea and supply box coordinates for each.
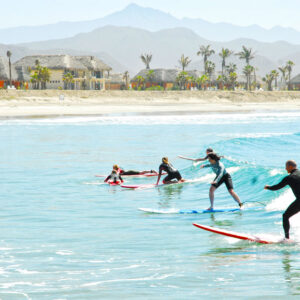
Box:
[0,90,300,118]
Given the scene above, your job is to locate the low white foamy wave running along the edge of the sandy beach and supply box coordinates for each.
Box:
[0,112,300,125]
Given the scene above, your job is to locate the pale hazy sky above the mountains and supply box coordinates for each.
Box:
[0,0,300,31]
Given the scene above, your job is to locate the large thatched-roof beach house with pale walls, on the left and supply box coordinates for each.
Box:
[14,55,111,90]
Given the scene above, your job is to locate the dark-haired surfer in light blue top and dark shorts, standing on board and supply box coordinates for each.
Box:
[201,153,243,210]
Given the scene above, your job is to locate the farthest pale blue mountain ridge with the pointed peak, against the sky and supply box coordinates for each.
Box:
[0,4,300,44]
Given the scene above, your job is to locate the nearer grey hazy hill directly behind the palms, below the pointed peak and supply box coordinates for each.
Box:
[22,26,300,75]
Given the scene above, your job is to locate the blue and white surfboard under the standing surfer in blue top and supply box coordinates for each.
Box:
[138,208,241,214]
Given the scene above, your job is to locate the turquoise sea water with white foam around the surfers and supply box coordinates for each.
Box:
[0,113,300,299]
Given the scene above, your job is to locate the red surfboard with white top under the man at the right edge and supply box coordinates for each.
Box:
[193,223,285,244]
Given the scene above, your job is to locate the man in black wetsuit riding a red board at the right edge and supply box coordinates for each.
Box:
[265,160,300,239]
